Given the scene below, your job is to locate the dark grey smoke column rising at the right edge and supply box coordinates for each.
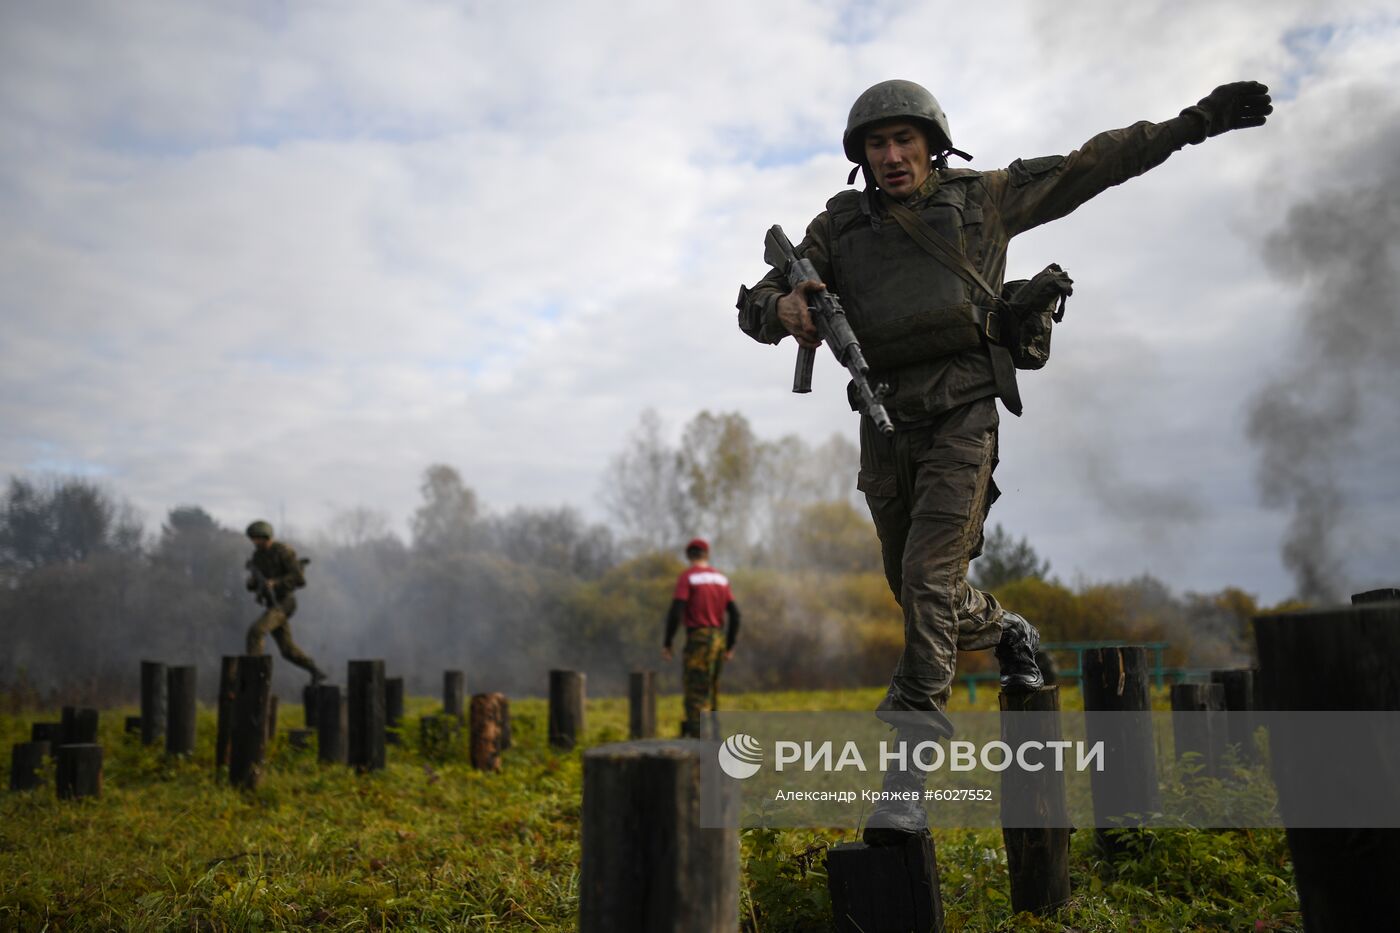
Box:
[1247,91,1400,604]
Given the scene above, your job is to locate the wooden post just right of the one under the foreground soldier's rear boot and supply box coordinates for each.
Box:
[1079,644,1162,855]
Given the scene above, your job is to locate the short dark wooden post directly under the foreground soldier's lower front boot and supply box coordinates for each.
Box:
[826,832,944,933]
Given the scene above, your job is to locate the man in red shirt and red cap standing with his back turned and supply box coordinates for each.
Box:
[661,538,739,738]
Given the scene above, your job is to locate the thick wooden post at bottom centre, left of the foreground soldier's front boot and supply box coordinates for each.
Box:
[578,740,739,933]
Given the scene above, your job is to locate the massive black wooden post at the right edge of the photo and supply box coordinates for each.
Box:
[1254,601,1400,933]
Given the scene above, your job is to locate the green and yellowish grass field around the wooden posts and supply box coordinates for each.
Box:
[0,688,1302,933]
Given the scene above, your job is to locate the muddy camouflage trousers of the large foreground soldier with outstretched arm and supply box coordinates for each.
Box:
[857,398,1002,731]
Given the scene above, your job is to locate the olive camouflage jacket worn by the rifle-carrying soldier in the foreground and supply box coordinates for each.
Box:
[739,116,1200,426]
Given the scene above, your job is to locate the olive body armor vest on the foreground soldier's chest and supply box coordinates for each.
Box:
[827,171,983,371]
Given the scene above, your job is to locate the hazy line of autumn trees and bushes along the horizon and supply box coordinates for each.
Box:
[0,412,1282,705]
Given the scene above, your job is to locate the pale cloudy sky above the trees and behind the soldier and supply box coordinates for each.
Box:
[0,0,1400,601]
